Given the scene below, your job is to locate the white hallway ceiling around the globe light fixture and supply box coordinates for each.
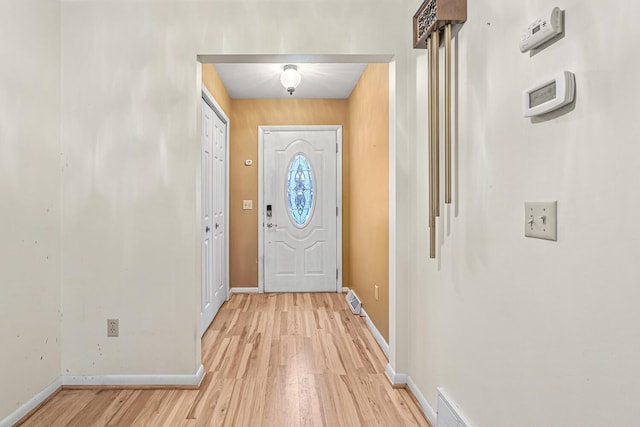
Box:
[214,62,367,99]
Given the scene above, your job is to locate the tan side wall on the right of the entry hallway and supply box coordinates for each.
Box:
[348,64,389,342]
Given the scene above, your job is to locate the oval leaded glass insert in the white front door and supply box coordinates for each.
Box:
[287,153,315,227]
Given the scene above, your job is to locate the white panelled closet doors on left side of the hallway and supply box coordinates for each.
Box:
[200,99,227,334]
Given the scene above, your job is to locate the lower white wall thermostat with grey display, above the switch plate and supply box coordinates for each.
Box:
[522,71,576,117]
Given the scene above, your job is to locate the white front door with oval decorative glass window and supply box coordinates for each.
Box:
[262,128,339,292]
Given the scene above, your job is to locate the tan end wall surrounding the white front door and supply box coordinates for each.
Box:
[229,99,350,287]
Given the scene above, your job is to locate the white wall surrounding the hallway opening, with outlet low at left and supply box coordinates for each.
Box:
[62,0,417,375]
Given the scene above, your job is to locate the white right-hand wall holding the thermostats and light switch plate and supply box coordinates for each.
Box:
[408,0,640,427]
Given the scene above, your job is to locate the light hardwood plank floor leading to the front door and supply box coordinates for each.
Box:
[22,293,429,427]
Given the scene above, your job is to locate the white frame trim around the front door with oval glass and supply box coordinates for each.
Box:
[258,125,342,293]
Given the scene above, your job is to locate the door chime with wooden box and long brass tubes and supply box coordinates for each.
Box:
[413,0,467,258]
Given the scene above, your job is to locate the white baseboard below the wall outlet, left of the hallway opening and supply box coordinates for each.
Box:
[60,365,204,386]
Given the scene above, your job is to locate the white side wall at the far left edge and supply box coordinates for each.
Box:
[0,0,60,420]
